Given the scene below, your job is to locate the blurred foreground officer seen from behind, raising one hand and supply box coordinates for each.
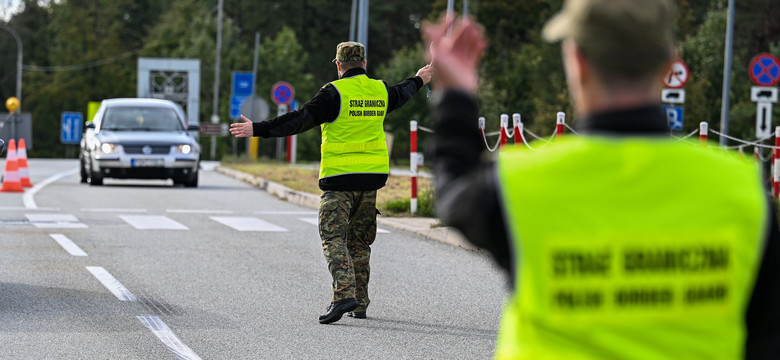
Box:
[424,0,780,359]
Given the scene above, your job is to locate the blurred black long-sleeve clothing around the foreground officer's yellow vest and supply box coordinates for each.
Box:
[428,91,780,359]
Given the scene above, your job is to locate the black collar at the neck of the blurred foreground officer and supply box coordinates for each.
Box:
[576,104,669,135]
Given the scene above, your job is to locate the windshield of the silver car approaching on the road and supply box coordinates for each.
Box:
[100,107,184,131]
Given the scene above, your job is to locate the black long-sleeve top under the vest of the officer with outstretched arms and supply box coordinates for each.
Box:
[252,68,423,191]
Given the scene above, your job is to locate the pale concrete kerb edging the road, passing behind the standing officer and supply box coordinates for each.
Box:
[214,166,476,250]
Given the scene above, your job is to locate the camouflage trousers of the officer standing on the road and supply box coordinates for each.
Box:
[319,190,377,311]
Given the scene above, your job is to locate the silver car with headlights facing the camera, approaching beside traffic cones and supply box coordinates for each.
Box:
[79,98,200,187]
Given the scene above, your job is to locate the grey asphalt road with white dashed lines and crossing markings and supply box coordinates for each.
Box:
[0,159,506,359]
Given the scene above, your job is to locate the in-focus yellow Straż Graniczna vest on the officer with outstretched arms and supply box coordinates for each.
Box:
[320,75,390,178]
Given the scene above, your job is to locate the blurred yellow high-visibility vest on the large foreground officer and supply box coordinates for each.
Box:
[496,136,768,359]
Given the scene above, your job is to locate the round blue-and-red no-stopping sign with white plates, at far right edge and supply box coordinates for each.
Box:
[748,53,780,139]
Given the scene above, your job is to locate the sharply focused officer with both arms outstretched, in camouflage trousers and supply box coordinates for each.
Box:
[230,42,431,324]
